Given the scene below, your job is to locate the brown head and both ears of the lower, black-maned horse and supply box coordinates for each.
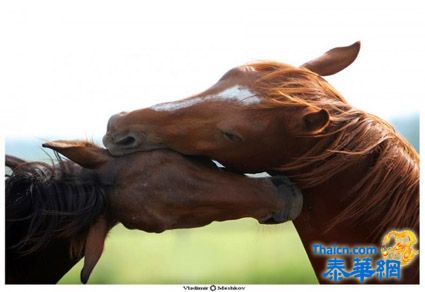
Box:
[38,141,302,283]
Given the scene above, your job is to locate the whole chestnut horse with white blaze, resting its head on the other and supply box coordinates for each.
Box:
[103,42,419,283]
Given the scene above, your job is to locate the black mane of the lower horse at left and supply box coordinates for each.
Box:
[5,153,107,256]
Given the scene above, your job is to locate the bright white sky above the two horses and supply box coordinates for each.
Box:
[0,0,425,138]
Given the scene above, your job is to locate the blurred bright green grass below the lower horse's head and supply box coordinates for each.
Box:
[59,219,317,284]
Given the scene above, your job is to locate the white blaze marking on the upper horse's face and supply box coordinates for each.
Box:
[151,85,261,111]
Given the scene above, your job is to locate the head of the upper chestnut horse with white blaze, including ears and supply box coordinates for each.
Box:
[103,42,360,172]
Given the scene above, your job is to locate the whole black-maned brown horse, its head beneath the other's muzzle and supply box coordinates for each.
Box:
[6,141,302,284]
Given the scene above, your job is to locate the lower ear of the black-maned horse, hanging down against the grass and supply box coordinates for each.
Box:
[80,216,109,284]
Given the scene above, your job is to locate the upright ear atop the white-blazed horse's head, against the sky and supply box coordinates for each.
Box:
[301,42,360,76]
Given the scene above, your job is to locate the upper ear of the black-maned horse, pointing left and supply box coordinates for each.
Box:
[43,140,111,169]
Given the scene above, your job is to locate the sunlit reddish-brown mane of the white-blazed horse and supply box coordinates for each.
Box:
[249,62,419,234]
